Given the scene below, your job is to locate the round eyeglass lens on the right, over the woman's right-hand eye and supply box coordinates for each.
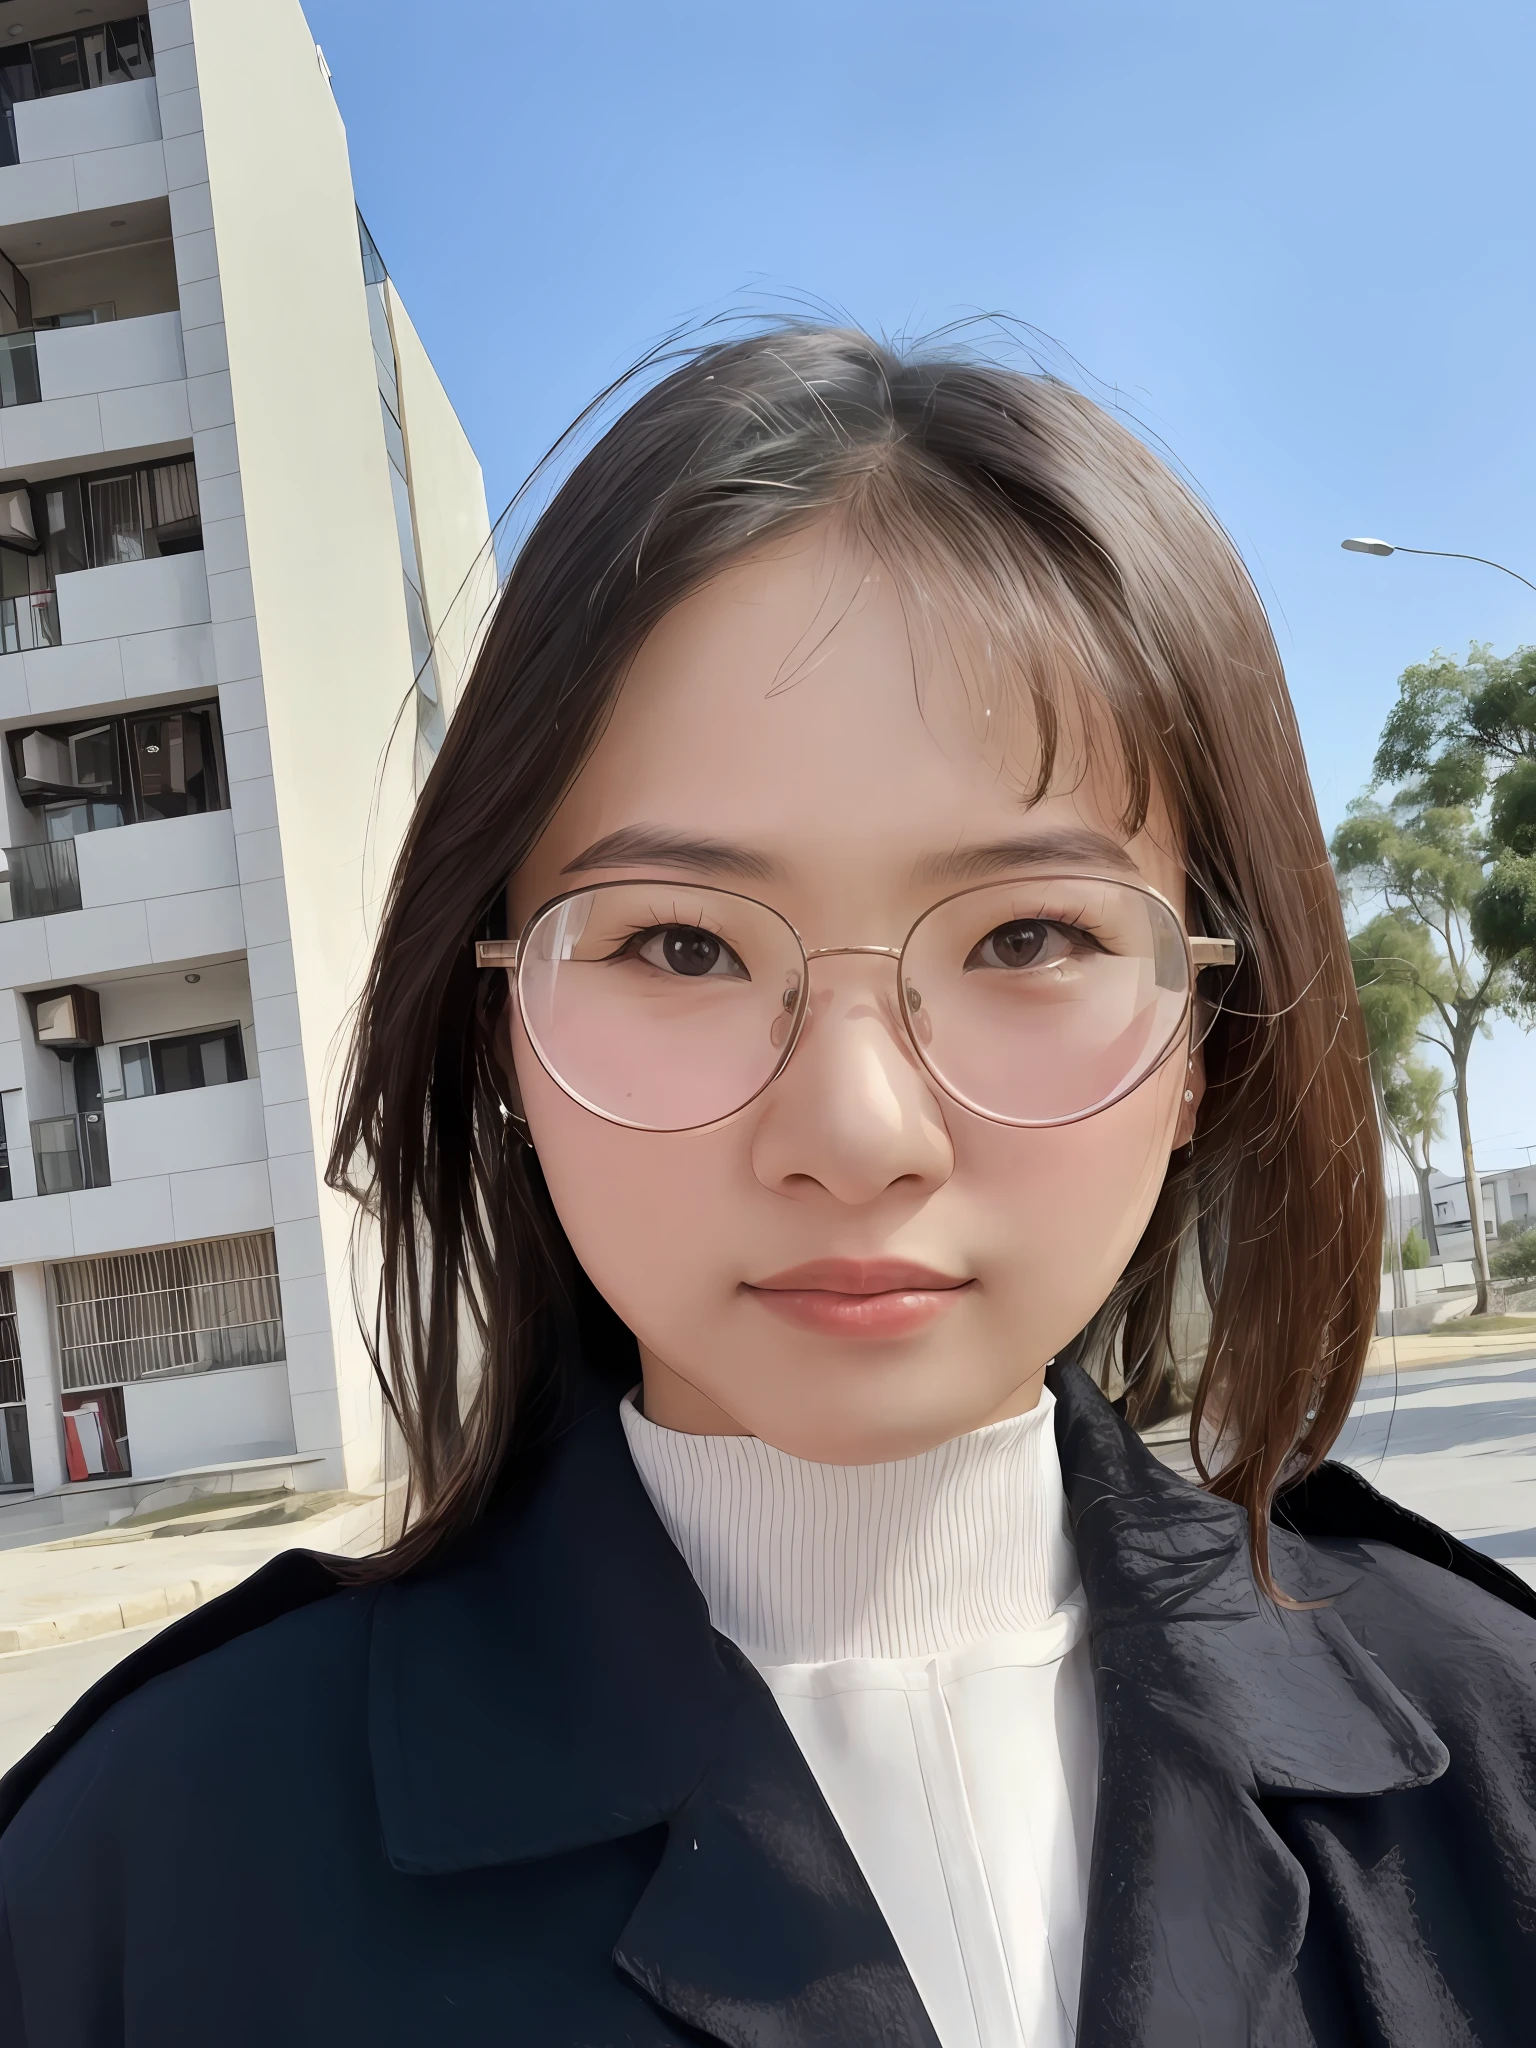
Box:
[901,877,1190,1124]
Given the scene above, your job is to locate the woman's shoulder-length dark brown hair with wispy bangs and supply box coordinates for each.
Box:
[328,326,1382,1583]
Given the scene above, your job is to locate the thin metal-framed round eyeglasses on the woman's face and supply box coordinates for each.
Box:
[475,874,1237,1130]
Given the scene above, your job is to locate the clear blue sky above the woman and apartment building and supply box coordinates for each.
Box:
[305,0,1536,1167]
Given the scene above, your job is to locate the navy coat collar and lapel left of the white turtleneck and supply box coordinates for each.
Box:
[369,1391,938,2048]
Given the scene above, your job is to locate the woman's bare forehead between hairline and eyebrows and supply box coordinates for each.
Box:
[535,524,1180,893]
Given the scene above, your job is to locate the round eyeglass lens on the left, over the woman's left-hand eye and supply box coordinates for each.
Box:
[518,881,805,1130]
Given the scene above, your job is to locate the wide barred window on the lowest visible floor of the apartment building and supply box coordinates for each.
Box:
[51,1231,285,1395]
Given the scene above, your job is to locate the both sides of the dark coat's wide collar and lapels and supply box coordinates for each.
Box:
[369,1366,1446,2048]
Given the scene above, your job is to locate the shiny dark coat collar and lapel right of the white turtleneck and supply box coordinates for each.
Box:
[1051,1366,1448,2048]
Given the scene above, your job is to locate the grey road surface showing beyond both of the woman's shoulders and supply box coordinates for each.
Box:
[0,1356,1536,1769]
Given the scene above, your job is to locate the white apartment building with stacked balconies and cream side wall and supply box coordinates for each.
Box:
[0,0,494,1544]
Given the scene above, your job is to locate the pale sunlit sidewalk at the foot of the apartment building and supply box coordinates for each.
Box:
[0,1489,383,1654]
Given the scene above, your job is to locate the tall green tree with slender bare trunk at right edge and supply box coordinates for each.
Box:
[1333,645,1536,1315]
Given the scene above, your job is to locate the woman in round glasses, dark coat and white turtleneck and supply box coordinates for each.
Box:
[0,328,1536,2048]
